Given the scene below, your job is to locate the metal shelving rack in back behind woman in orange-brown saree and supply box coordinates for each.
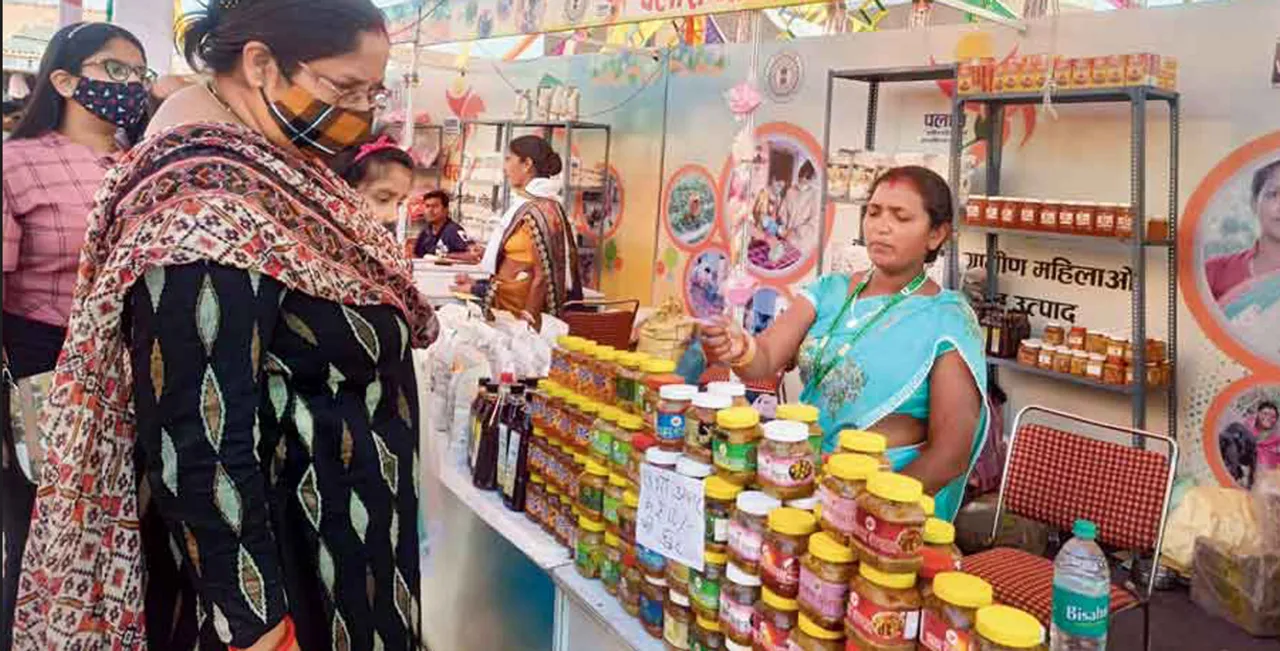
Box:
[456,120,613,286]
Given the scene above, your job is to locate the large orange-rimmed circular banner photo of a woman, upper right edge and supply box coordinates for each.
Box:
[1178,132,1280,371]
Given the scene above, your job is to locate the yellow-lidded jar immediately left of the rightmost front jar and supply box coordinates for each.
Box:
[920,572,993,651]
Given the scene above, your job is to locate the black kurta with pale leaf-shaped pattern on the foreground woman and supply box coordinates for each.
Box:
[125,263,419,651]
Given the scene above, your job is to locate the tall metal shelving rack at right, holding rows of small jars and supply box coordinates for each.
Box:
[951,86,1179,436]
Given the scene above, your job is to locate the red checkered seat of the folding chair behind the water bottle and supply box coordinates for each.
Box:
[961,547,1138,625]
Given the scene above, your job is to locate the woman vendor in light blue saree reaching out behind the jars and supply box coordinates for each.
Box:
[699,166,987,521]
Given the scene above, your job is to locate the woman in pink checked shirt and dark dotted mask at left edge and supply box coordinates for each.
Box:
[0,23,151,648]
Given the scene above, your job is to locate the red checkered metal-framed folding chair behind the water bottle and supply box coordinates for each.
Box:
[963,405,1178,650]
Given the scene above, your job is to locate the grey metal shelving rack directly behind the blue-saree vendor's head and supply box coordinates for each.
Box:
[818,64,964,288]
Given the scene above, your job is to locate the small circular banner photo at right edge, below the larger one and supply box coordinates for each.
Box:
[1203,377,1280,489]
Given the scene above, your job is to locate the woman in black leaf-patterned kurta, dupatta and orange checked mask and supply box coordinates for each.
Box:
[15,0,436,651]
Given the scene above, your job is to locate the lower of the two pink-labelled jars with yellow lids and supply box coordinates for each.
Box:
[796,531,856,631]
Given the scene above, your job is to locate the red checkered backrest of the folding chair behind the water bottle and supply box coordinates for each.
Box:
[1004,425,1169,551]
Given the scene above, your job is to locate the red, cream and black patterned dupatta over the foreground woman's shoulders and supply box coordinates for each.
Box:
[14,124,438,650]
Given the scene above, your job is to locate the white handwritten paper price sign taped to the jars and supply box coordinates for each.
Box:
[636,464,707,572]
